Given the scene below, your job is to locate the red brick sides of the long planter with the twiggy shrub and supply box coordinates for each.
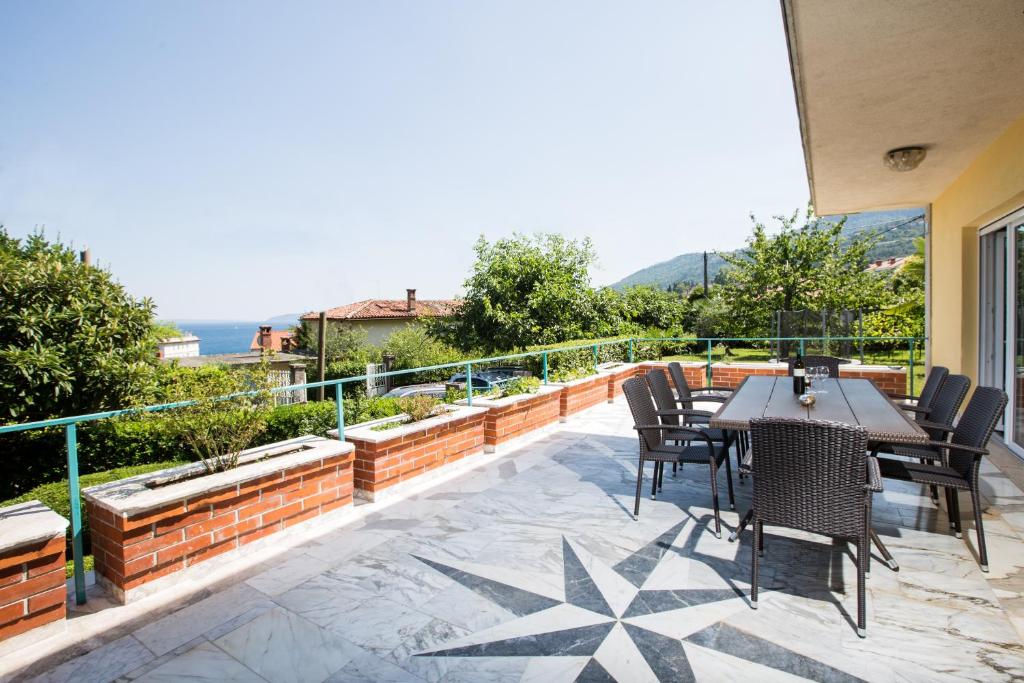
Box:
[86,453,360,591]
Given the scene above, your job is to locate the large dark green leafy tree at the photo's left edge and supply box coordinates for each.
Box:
[0,226,158,421]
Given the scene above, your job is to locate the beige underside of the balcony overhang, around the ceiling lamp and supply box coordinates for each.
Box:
[781,0,1024,215]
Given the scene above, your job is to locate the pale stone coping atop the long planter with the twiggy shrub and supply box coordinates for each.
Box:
[82,436,355,517]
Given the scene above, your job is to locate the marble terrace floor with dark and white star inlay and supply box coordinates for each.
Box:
[9,401,1024,682]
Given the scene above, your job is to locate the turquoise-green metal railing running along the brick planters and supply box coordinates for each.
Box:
[0,337,924,604]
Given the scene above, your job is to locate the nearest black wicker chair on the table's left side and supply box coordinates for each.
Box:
[623,377,735,539]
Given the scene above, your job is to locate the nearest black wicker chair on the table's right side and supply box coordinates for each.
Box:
[876,387,1007,571]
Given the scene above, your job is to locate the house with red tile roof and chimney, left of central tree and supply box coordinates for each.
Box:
[299,290,459,344]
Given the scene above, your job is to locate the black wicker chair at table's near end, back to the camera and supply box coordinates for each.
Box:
[744,418,882,638]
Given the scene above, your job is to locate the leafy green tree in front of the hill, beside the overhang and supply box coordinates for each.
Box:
[720,210,885,336]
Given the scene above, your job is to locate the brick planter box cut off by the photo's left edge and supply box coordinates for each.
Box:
[0,501,68,646]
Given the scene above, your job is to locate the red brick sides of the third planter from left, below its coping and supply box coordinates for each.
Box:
[345,409,485,493]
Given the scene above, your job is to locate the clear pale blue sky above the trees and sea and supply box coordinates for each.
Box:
[0,0,808,319]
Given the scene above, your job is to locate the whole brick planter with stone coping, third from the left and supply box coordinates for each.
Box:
[331,401,487,501]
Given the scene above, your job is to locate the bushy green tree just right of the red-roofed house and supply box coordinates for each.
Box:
[431,233,595,352]
